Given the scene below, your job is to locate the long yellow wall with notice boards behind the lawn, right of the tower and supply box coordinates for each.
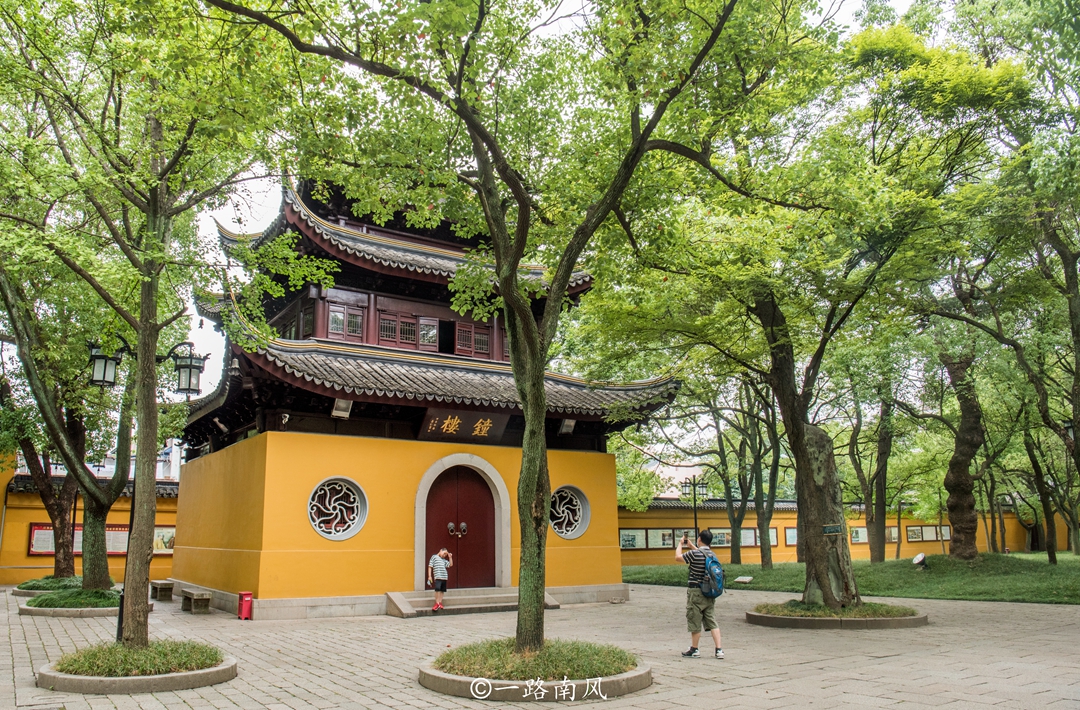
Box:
[619,508,1068,565]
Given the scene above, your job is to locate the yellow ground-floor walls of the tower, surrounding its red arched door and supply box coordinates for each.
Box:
[173,432,622,599]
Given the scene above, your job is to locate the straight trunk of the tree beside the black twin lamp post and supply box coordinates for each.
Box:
[123,265,159,647]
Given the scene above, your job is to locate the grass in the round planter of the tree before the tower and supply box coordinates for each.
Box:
[435,639,637,681]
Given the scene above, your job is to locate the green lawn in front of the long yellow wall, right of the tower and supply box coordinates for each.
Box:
[622,552,1080,604]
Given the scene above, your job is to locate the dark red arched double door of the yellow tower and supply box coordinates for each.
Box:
[423,466,495,589]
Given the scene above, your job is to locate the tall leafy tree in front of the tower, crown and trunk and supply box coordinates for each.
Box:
[196,0,825,652]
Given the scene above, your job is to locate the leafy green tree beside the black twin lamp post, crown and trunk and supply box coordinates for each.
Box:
[0,1,308,646]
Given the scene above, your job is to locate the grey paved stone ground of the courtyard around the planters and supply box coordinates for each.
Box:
[0,586,1080,710]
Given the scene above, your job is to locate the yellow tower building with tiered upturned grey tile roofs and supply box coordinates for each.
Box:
[173,186,677,619]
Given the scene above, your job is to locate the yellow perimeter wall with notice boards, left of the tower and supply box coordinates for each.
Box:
[0,457,176,585]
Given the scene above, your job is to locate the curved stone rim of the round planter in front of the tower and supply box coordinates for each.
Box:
[420,664,652,702]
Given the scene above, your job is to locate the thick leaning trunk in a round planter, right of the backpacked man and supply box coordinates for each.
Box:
[754,295,861,609]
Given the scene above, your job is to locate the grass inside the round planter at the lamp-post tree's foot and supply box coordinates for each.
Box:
[56,641,225,678]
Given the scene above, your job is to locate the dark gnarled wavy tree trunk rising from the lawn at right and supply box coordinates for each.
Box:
[939,353,985,560]
